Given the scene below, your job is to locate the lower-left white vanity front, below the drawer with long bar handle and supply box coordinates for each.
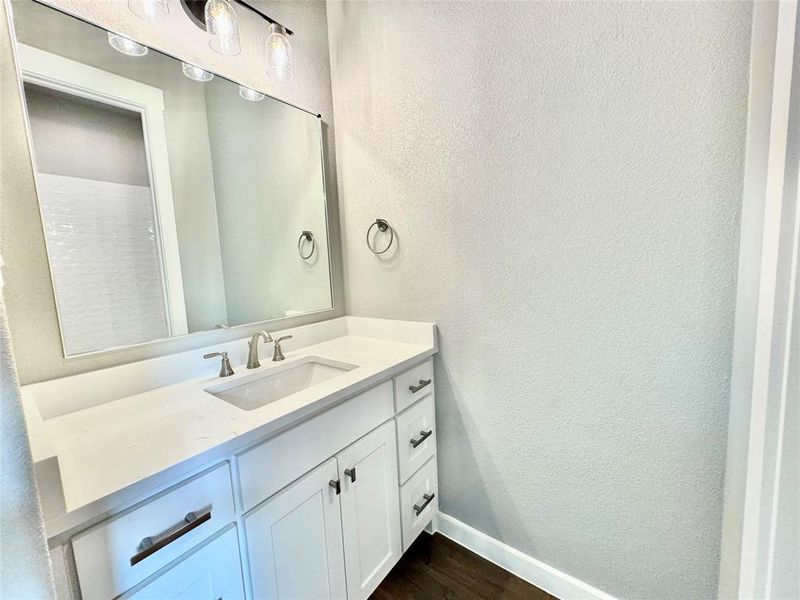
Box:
[123,527,244,600]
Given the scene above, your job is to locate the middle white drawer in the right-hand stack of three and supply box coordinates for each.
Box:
[396,396,436,483]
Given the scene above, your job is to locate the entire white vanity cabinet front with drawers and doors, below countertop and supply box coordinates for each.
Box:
[64,359,438,600]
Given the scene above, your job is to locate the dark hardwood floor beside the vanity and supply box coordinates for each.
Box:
[370,532,554,600]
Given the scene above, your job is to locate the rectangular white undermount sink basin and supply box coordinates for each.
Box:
[205,356,356,410]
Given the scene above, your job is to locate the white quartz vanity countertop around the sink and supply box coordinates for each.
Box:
[23,322,436,529]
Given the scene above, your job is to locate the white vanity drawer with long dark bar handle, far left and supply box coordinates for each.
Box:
[72,462,235,600]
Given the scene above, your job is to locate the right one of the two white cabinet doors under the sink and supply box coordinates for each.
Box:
[336,421,402,600]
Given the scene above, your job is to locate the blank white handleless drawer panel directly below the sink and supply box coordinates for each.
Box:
[237,381,394,511]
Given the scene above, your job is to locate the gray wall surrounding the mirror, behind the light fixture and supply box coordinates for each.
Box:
[0,0,344,384]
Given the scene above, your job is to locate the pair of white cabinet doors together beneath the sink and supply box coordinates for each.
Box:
[245,422,402,600]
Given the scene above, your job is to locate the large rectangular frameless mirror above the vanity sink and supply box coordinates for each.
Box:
[7,1,332,356]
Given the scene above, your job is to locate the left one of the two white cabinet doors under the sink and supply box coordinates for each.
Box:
[245,458,347,600]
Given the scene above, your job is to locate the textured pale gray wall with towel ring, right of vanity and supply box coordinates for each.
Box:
[328,2,751,600]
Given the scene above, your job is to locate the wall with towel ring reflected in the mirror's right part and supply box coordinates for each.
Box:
[205,80,331,325]
